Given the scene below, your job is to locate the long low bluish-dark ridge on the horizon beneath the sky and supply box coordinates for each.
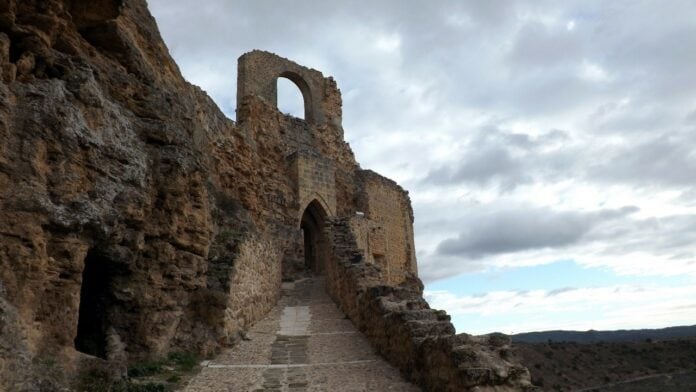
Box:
[510,325,696,343]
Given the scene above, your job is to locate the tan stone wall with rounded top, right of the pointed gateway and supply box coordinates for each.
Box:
[353,170,418,284]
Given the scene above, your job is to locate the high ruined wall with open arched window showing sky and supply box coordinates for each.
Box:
[237,50,359,216]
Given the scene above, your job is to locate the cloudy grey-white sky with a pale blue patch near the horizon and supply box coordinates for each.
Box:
[150,0,696,334]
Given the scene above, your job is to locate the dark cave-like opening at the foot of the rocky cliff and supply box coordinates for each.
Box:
[75,250,113,358]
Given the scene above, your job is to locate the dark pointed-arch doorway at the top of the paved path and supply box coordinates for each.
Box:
[300,200,327,273]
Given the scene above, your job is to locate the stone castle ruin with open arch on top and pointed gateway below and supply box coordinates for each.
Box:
[237,51,417,284]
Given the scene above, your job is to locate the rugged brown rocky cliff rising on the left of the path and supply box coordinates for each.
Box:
[0,0,247,390]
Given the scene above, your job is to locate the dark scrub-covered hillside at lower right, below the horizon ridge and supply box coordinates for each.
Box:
[513,338,696,392]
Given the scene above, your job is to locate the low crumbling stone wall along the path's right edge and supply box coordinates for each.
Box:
[326,219,536,392]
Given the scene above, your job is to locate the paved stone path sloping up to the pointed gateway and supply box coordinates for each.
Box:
[184,277,420,392]
